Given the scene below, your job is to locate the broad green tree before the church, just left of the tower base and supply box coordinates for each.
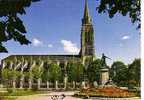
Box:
[67,63,84,82]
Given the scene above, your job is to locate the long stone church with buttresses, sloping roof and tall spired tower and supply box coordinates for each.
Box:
[1,0,95,88]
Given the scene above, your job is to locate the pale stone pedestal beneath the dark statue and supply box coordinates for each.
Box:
[100,68,109,85]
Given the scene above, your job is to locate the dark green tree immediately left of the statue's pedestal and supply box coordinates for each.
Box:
[87,59,101,85]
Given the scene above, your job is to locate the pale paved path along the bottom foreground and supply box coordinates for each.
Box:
[17,92,140,100]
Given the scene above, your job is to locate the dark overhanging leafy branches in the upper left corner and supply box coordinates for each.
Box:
[0,0,40,52]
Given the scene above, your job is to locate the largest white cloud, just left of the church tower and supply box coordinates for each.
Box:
[61,40,79,54]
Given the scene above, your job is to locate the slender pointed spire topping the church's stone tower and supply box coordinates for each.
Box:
[82,0,91,24]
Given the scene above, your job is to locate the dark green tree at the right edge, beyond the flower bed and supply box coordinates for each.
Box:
[128,59,141,86]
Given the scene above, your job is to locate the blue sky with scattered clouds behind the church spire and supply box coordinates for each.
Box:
[0,0,140,65]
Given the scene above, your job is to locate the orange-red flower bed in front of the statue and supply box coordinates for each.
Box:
[75,87,136,98]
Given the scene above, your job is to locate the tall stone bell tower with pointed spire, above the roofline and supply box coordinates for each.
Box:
[80,0,95,57]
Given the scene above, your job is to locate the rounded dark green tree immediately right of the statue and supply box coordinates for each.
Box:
[110,61,128,86]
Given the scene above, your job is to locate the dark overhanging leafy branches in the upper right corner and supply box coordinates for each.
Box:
[97,0,141,28]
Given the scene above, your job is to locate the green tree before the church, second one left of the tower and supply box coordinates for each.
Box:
[48,64,62,81]
